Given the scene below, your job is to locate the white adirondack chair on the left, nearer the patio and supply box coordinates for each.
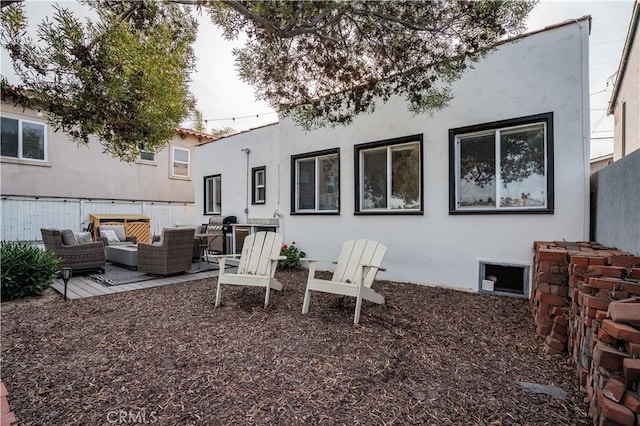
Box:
[211,232,286,308]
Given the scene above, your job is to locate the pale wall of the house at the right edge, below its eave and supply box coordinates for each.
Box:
[613,20,640,161]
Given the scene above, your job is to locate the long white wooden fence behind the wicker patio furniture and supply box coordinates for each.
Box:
[0,197,196,242]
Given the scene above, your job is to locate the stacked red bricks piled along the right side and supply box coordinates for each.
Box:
[531,242,640,426]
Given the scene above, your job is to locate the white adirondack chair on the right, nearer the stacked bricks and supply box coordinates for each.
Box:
[302,240,387,324]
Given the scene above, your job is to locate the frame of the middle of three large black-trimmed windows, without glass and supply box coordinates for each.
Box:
[355,135,424,215]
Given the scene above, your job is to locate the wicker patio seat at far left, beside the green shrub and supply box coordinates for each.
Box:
[40,228,106,273]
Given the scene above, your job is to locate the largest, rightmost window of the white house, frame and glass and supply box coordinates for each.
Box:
[449,113,553,213]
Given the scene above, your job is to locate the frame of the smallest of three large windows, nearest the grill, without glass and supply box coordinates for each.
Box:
[291,149,340,214]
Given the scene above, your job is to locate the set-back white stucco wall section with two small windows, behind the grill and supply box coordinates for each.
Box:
[194,125,280,223]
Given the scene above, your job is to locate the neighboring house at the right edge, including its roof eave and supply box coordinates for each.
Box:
[607,0,640,161]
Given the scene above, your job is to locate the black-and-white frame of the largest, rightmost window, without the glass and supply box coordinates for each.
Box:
[449,113,554,214]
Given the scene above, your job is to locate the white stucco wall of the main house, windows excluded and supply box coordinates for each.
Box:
[196,21,589,291]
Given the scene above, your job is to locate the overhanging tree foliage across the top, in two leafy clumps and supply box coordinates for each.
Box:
[2,0,535,160]
